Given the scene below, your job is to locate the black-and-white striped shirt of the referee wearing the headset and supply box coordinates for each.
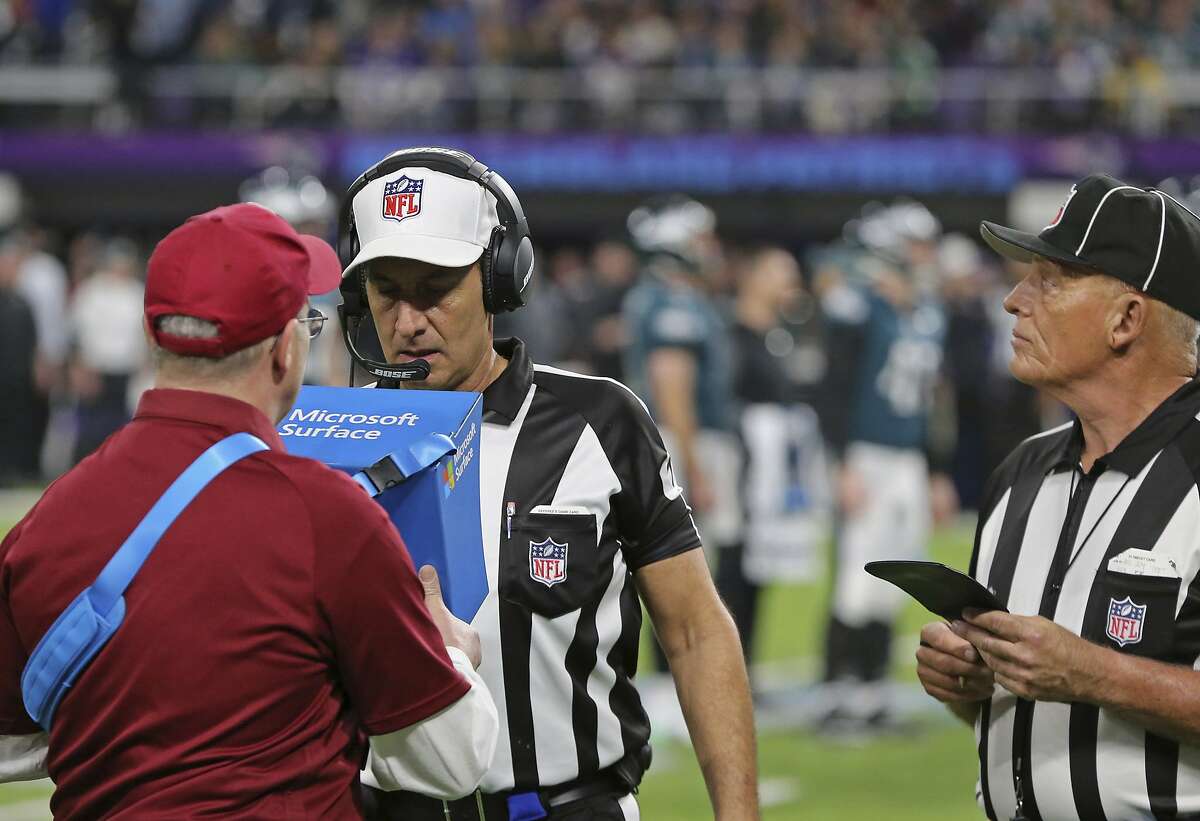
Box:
[451,340,700,792]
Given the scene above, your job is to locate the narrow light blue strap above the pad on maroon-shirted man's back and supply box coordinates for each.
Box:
[89,433,268,615]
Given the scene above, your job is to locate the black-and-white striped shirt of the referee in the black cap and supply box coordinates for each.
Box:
[971,380,1200,821]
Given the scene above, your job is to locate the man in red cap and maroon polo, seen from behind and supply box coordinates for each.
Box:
[0,204,497,819]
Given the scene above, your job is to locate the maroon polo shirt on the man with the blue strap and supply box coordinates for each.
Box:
[0,390,470,819]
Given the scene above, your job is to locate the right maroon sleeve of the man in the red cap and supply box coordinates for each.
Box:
[314,506,470,736]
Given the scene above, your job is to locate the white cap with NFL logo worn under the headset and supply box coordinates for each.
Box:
[342,167,500,276]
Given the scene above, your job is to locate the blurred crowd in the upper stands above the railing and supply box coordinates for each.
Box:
[0,0,1200,68]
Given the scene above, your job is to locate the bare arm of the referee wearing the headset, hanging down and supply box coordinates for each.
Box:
[635,550,758,821]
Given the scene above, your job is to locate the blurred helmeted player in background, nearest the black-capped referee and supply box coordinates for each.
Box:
[817,200,954,733]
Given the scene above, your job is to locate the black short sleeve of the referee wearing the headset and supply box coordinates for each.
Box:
[613,390,700,569]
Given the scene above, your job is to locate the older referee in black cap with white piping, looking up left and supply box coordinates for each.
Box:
[917,175,1200,821]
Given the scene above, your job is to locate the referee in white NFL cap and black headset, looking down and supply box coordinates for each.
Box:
[342,149,757,821]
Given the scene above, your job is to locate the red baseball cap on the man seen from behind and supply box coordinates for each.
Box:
[145,203,342,358]
